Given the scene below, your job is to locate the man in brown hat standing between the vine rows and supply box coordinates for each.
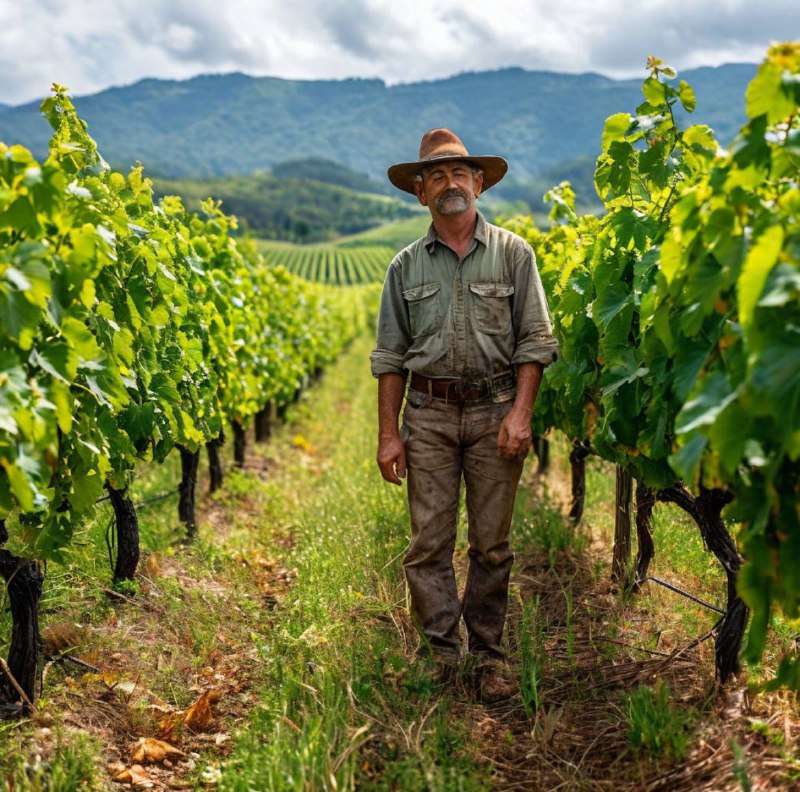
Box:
[370,129,558,701]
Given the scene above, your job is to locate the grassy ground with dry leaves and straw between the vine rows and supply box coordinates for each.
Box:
[0,338,800,792]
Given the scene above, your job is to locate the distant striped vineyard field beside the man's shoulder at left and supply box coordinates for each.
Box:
[259,248,396,286]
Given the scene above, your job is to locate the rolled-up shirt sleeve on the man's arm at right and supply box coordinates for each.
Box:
[511,240,559,366]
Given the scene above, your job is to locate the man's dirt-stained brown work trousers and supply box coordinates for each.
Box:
[401,390,523,658]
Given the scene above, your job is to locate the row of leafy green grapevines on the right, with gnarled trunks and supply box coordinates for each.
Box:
[507,48,800,689]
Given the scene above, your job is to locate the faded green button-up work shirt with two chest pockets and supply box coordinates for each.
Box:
[370,213,558,381]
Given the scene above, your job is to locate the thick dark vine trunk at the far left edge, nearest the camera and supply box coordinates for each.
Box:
[0,520,44,701]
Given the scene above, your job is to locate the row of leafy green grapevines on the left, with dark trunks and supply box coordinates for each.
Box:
[0,86,382,700]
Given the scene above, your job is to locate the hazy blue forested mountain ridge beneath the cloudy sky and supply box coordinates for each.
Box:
[0,63,755,180]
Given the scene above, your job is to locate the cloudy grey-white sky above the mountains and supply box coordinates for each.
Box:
[0,0,800,104]
